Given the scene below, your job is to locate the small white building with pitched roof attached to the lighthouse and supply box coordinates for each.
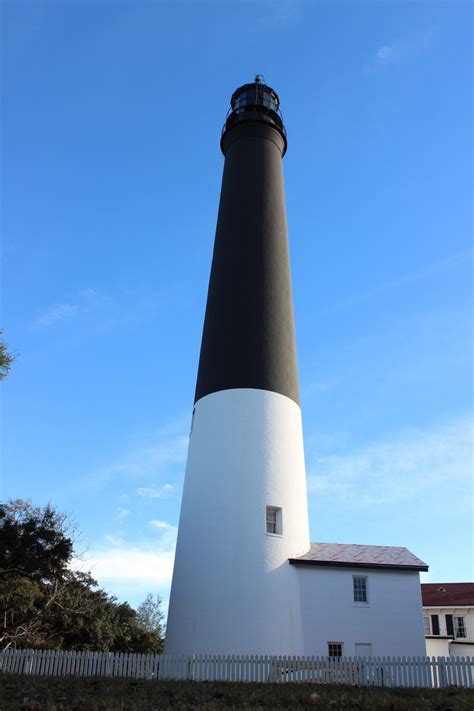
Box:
[289,543,428,657]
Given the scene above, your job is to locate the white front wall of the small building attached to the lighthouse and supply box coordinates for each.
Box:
[295,565,426,656]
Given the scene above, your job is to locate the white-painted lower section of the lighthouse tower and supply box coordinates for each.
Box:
[165,388,309,654]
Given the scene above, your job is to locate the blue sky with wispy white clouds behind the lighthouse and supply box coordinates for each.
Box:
[1,0,473,616]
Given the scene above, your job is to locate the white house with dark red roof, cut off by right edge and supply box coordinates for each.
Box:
[421,583,474,657]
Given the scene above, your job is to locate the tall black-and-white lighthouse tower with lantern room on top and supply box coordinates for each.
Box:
[165,76,310,654]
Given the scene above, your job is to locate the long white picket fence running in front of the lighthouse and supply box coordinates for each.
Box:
[0,650,474,689]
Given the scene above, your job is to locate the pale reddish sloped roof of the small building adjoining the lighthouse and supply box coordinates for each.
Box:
[290,543,428,570]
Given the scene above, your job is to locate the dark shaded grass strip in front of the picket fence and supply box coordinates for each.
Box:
[0,674,474,711]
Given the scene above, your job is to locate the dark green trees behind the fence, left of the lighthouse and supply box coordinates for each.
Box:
[0,500,162,652]
